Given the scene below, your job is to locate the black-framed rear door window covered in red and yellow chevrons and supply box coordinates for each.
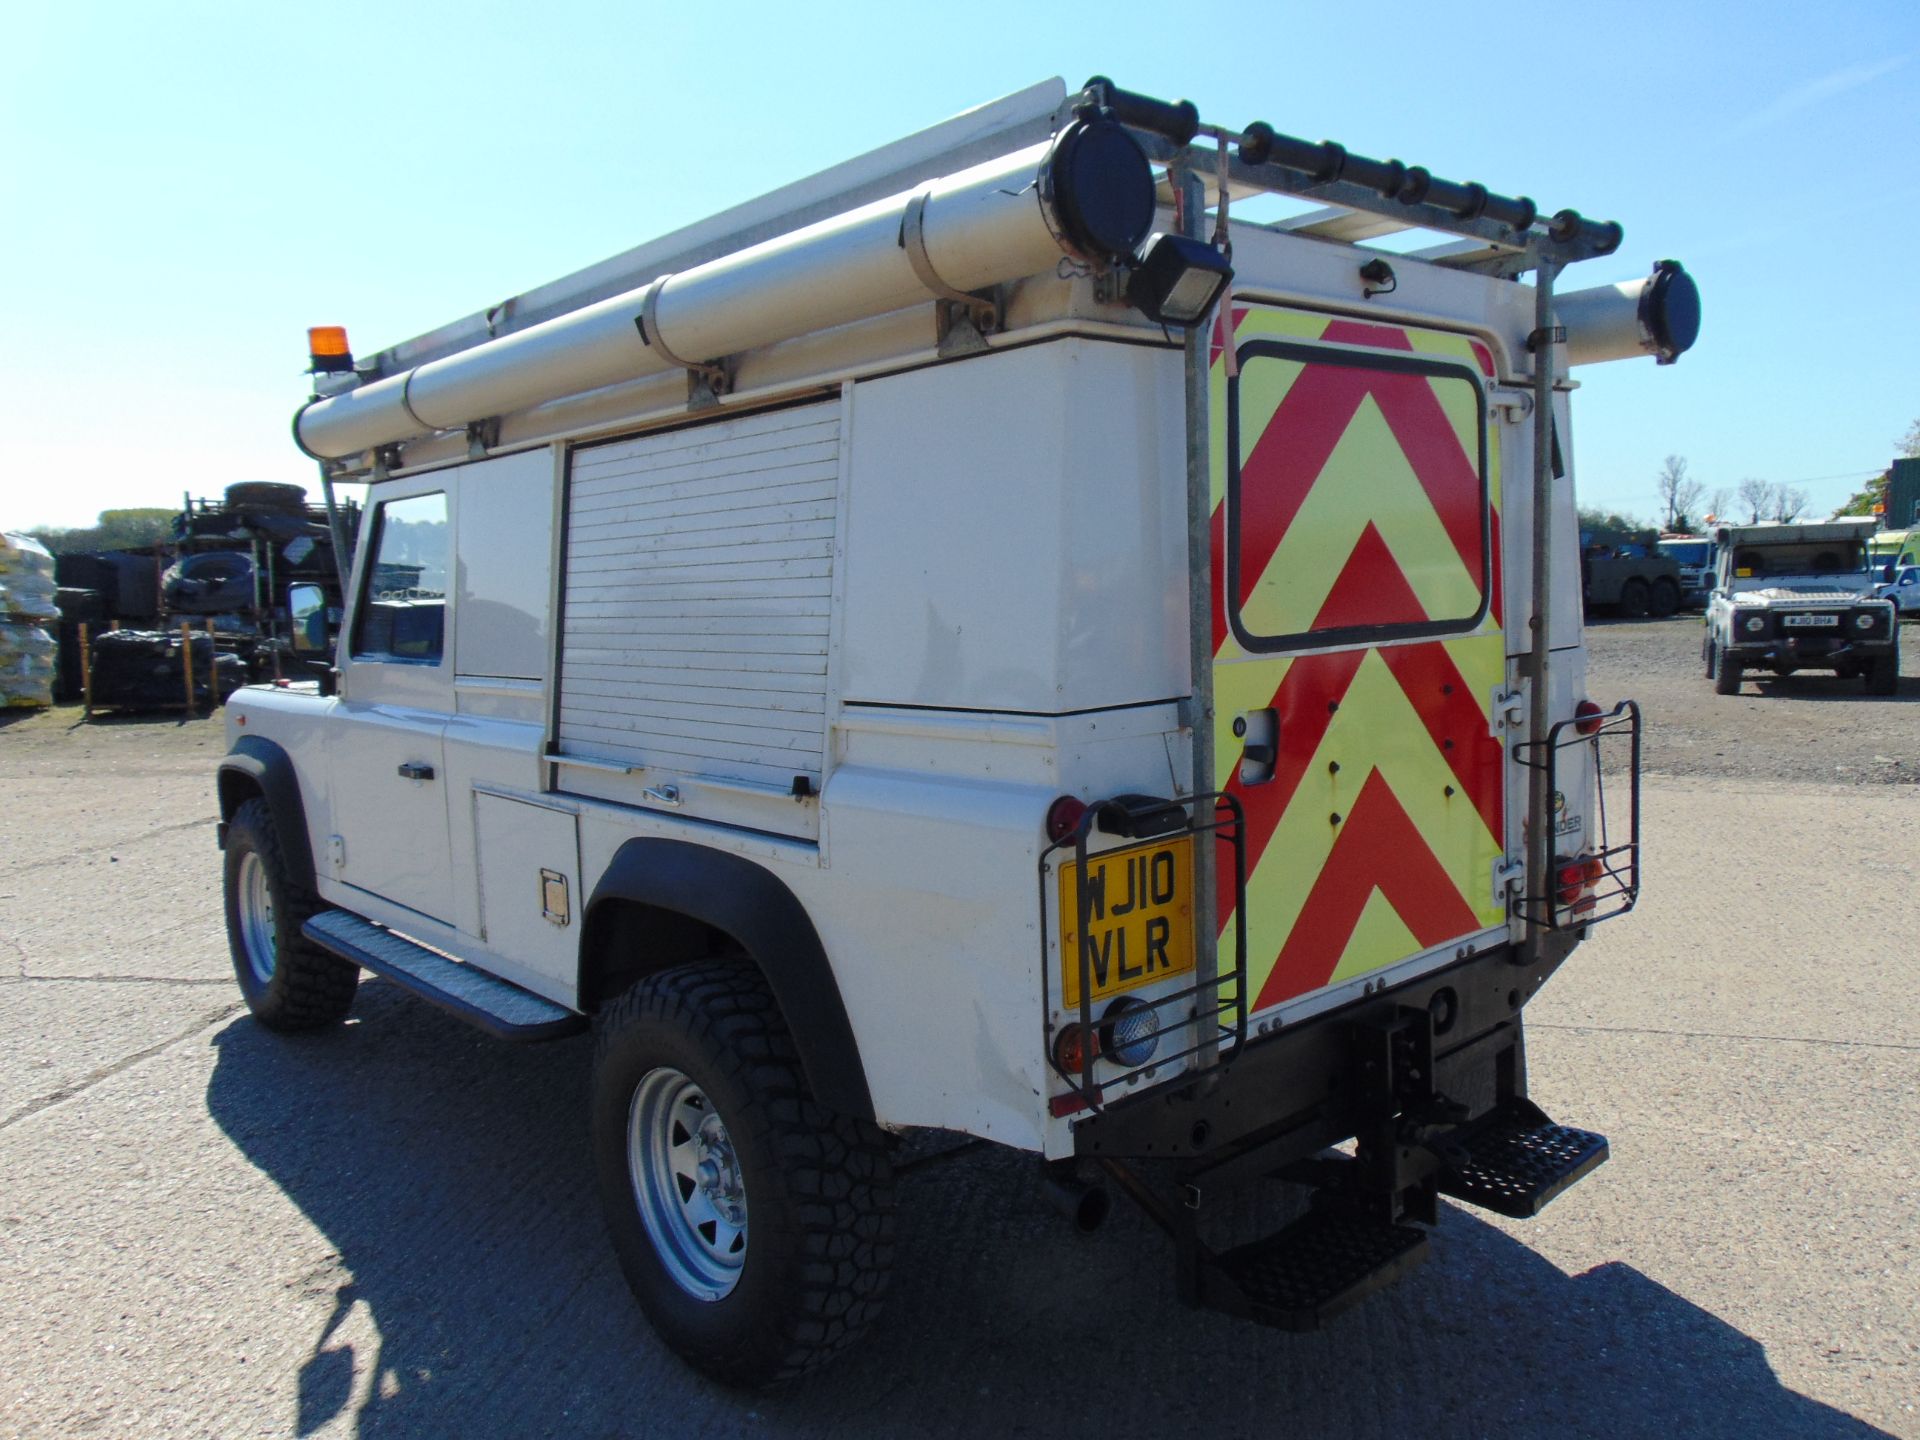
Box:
[1227,342,1494,653]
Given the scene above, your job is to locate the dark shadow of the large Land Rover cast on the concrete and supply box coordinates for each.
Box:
[207,981,1882,1440]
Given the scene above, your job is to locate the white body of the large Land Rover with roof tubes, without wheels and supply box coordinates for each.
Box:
[210,83,1692,1374]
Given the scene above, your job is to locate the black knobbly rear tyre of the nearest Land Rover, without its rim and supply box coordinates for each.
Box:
[591,960,893,1388]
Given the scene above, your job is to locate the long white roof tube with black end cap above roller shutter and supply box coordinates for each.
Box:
[294,119,1154,459]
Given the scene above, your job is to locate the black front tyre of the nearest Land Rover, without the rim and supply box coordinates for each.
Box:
[225,797,359,1031]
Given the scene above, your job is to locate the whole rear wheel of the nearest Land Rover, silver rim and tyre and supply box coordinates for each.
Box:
[593,960,893,1388]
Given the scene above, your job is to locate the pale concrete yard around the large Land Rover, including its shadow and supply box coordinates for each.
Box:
[0,683,1920,1440]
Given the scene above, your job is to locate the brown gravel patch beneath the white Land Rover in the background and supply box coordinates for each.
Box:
[1588,614,1920,785]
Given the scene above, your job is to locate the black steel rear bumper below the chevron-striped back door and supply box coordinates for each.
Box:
[1073,931,1584,1167]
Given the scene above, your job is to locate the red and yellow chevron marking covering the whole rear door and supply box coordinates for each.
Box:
[1213,307,1505,1008]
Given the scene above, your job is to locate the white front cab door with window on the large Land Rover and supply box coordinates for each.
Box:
[328,478,453,922]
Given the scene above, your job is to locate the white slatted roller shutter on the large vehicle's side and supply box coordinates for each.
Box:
[555,399,843,839]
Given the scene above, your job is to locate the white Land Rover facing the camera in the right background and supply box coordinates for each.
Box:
[1703,516,1901,695]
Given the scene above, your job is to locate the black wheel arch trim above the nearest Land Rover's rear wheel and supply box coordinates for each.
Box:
[578,837,876,1119]
